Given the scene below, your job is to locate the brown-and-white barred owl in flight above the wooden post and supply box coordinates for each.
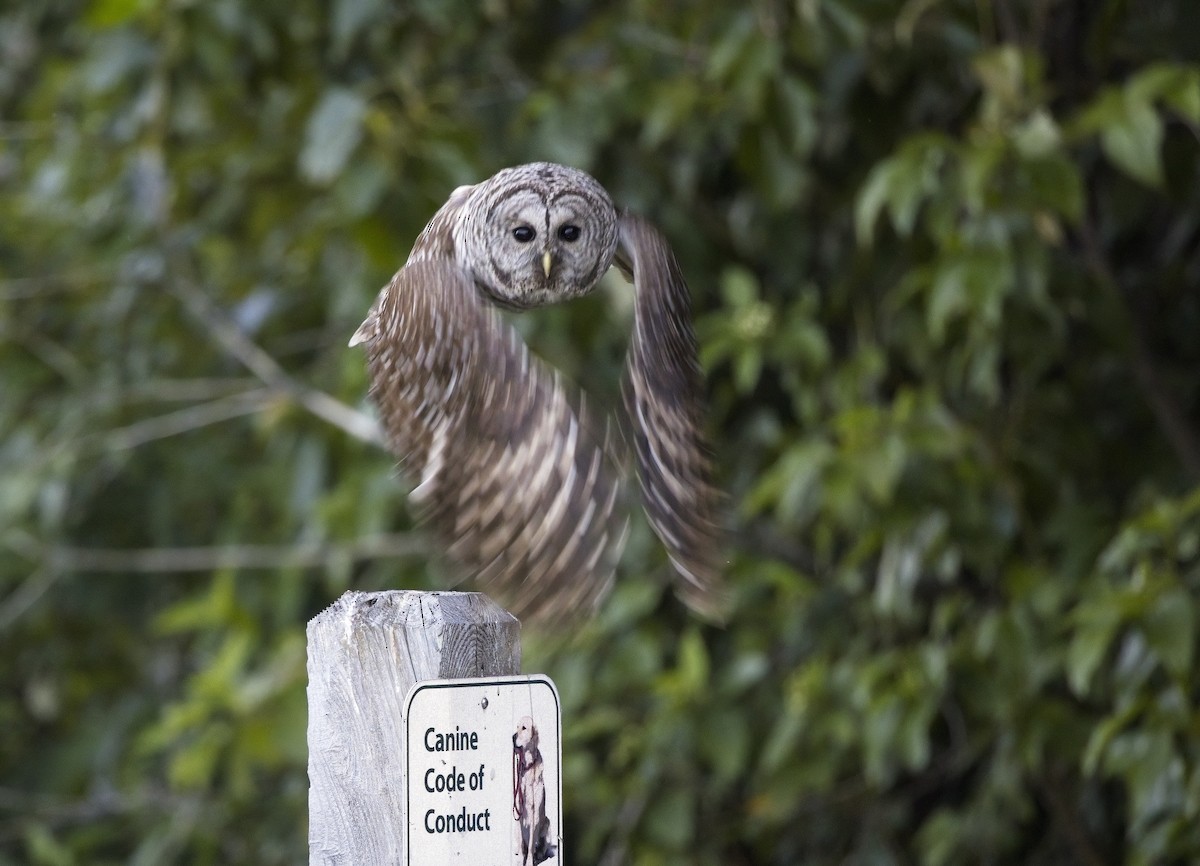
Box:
[350,163,721,618]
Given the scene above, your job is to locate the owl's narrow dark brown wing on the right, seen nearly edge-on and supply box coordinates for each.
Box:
[617,214,725,618]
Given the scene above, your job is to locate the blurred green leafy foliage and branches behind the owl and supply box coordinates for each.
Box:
[0,0,1200,866]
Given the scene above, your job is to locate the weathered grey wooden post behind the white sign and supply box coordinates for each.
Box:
[307,590,521,866]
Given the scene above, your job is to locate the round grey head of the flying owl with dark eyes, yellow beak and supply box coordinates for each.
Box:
[454,162,617,308]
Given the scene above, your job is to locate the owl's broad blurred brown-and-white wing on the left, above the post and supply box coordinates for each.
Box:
[364,259,624,618]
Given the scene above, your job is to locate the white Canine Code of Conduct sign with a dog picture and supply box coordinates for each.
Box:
[404,675,563,866]
